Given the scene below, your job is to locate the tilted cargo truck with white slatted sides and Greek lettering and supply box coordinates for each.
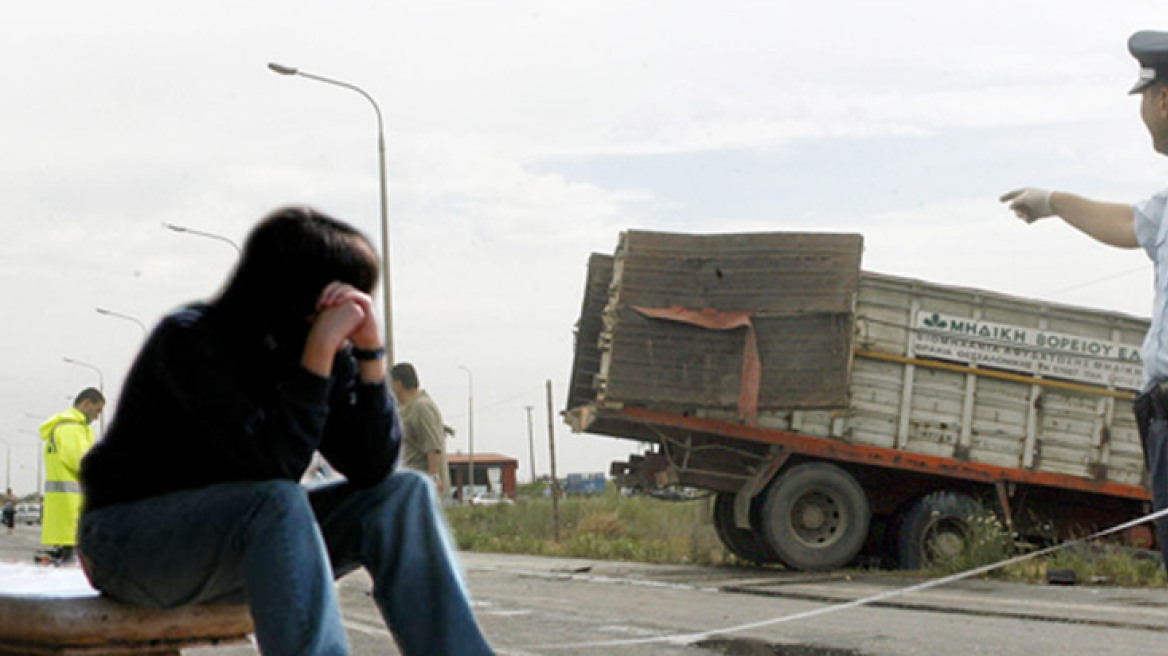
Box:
[564,231,1153,570]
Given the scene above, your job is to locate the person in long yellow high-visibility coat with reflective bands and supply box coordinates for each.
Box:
[41,388,105,565]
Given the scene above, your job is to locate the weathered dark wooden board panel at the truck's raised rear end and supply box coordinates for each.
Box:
[598,231,862,410]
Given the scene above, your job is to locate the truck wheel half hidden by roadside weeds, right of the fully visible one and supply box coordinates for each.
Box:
[897,491,986,570]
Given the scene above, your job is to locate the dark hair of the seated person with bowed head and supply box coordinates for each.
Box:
[215,207,378,330]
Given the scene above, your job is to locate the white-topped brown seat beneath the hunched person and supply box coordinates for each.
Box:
[0,563,252,656]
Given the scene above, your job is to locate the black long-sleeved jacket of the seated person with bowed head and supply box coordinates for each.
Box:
[81,305,402,509]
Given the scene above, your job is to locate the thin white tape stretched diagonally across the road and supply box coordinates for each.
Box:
[528,508,1168,650]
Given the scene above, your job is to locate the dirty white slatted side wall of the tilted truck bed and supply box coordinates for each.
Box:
[738,273,1147,486]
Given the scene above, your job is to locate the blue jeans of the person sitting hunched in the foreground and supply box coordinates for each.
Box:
[78,470,493,656]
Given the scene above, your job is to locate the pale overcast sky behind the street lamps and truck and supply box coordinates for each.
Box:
[0,0,1168,493]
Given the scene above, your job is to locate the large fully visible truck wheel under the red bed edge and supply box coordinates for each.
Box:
[762,462,870,571]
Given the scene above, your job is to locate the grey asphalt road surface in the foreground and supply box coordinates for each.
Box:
[0,518,1168,656]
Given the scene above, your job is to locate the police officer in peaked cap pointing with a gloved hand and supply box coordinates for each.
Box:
[1001,32,1168,567]
